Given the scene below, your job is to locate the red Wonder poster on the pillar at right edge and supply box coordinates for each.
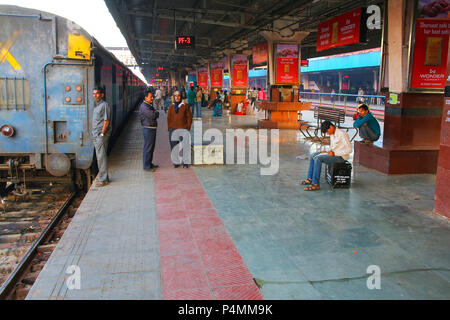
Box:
[411,19,450,89]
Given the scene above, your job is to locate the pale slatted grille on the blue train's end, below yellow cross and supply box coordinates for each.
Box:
[0,77,30,110]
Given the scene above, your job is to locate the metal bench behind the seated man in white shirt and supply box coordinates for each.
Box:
[299,107,358,144]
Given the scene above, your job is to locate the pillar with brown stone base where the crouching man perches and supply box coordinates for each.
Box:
[355,0,443,174]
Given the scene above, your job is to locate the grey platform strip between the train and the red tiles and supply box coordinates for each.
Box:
[27,110,161,300]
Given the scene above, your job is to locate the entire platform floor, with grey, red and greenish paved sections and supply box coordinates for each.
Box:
[27,109,450,300]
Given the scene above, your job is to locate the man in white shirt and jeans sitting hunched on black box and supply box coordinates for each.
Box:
[300,120,352,191]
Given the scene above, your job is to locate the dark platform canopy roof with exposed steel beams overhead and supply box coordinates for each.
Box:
[105,0,384,79]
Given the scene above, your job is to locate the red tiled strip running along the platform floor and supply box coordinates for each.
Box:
[154,115,262,300]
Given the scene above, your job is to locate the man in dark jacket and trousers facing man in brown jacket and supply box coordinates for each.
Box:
[139,89,159,171]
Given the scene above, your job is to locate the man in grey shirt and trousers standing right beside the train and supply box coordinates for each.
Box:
[92,87,112,187]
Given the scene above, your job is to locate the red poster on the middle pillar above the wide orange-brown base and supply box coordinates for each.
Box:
[275,44,298,84]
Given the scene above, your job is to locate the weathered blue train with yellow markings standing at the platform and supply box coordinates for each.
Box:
[0,5,146,192]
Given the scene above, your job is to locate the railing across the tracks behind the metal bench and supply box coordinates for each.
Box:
[299,91,386,114]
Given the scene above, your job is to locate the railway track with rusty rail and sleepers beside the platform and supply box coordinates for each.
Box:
[0,184,84,300]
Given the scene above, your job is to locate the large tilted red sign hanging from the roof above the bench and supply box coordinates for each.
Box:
[316,8,361,52]
